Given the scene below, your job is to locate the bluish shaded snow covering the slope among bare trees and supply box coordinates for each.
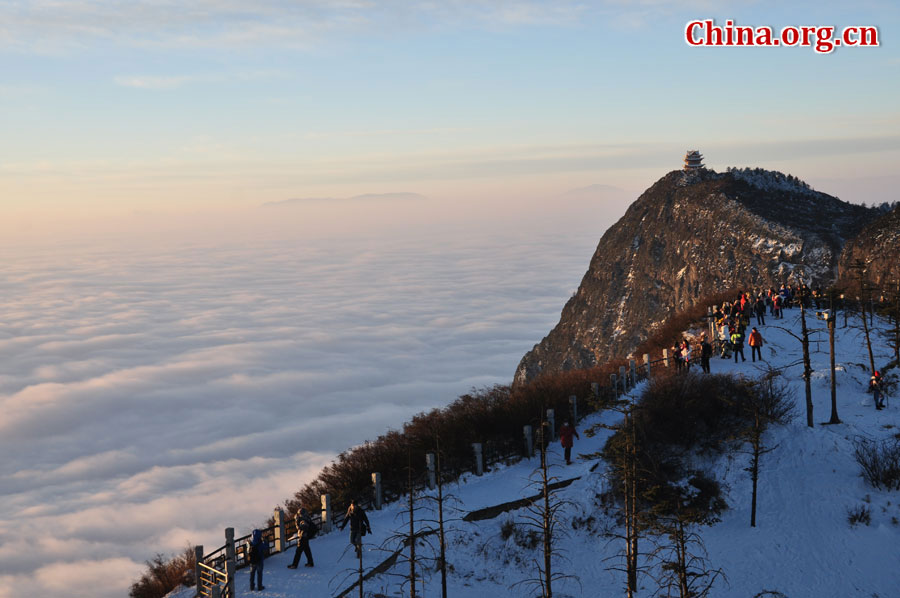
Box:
[173,309,900,598]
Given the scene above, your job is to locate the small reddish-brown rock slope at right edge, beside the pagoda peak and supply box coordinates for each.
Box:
[838,205,900,290]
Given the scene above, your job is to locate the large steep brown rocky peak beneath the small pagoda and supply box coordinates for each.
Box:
[514,169,874,384]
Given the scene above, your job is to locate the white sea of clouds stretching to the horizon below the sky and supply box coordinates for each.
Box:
[0,191,624,598]
